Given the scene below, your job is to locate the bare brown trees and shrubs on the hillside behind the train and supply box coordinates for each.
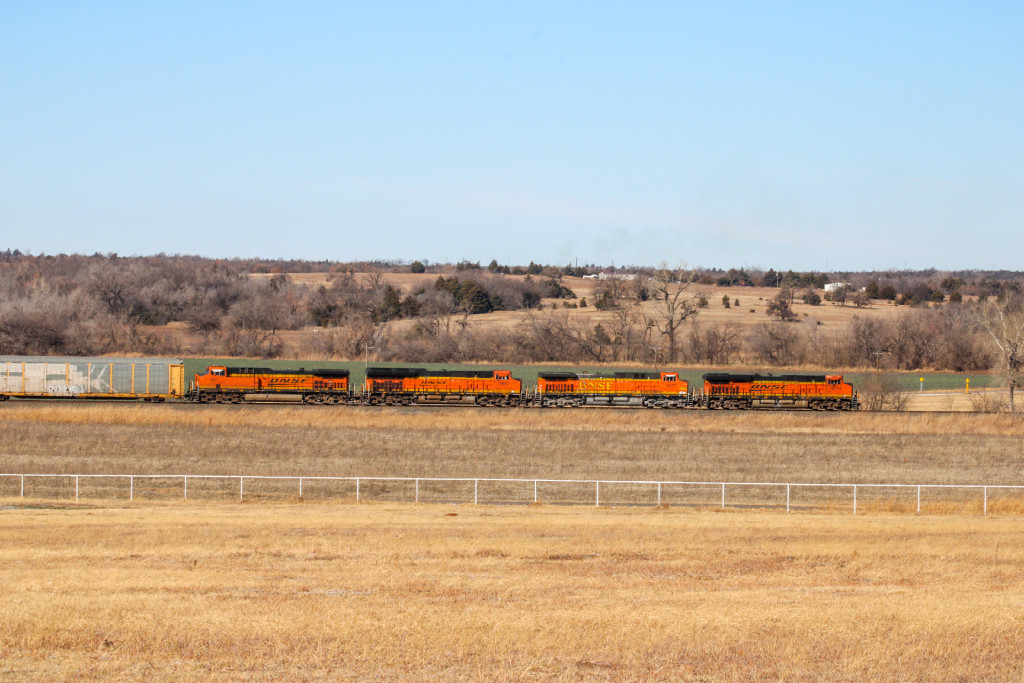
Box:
[0,251,1024,405]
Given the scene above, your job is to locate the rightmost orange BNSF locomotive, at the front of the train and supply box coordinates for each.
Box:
[700,373,857,411]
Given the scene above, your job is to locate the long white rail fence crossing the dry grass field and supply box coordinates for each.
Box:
[0,474,1024,515]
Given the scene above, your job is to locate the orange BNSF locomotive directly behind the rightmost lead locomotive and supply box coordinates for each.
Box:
[534,372,689,408]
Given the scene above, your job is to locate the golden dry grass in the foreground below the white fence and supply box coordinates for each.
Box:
[0,503,1024,681]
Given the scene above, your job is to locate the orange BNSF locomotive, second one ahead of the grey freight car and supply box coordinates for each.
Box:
[362,368,522,405]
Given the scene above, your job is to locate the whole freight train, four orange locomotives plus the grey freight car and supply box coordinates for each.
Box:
[0,356,859,411]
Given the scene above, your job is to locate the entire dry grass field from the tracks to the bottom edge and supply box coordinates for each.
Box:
[0,401,1024,681]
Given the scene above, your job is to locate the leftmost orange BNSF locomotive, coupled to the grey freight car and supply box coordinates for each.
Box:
[187,366,349,403]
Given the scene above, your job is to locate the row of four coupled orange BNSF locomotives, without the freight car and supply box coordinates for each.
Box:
[186,366,858,411]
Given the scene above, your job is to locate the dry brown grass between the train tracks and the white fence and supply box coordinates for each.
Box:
[0,403,1024,513]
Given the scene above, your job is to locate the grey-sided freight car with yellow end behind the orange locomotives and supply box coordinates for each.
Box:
[0,355,185,401]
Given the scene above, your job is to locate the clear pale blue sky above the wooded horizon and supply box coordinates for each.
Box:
[0,0,1024,270]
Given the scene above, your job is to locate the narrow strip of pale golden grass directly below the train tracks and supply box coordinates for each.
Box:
[8,403,1024,436]
